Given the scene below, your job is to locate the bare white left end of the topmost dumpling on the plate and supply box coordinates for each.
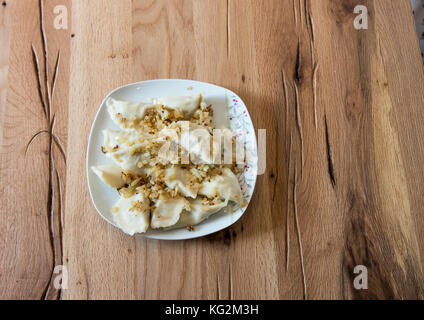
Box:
[106,98,159,130]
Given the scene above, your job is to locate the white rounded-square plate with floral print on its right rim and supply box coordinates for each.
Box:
[87,79,258,240]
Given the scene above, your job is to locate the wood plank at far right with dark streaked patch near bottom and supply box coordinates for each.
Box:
[308,1,423,298]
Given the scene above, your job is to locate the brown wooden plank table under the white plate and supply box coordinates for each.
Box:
[0,0,424,299]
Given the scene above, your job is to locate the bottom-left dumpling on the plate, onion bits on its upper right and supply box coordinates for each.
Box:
[112,194,150,236]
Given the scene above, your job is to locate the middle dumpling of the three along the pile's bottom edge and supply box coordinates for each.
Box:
[151,196,190,229]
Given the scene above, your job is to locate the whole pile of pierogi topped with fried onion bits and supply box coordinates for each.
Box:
[92,94,247,235]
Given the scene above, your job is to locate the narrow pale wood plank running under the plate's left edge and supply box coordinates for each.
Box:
[63,0,136,299]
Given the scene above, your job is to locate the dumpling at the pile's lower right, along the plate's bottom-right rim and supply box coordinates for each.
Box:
[172,198,228,229]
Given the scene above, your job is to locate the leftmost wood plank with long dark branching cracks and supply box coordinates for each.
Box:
[0,1,69,299]
